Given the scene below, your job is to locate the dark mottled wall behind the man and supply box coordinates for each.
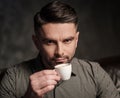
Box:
[0,0,120,68]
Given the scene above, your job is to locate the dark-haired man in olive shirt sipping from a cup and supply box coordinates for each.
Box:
[0,1,120,98]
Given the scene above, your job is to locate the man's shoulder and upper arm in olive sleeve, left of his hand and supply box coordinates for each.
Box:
[0,60,36,96]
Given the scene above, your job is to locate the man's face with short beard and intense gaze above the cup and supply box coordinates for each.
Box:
[33,23,79,67]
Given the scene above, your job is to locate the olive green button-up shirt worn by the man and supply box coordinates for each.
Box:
[0,58,120,98]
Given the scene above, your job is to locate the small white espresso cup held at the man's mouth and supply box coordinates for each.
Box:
[55,63,72,80]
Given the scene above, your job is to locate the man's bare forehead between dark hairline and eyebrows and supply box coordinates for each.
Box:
[39,23,76,38]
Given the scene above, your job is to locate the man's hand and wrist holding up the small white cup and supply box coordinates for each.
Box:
[25,70,60,98]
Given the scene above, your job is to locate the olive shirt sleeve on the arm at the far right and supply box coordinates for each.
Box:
[93,63,120,98]
